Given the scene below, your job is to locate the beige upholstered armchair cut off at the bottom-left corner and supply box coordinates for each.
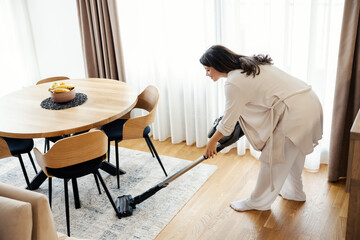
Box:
[0,183,83,240]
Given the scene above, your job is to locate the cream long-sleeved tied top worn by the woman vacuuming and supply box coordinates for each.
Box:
[217,65,323,163]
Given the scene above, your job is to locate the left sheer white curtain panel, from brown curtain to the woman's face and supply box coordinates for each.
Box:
[117,0,218,147]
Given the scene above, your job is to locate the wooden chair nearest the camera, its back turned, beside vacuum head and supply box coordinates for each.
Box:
[34,130,116,236]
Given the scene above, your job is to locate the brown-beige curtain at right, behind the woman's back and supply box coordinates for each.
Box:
[328,0,360,182]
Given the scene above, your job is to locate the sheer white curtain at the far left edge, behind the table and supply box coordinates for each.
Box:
[0,0,39,96]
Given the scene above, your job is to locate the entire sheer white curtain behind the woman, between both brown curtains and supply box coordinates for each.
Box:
[118,0,344,169]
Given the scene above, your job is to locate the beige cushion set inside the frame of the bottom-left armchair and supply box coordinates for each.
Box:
[0,197,32,240]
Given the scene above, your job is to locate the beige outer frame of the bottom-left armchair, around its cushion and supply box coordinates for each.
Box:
[0,183,57,240]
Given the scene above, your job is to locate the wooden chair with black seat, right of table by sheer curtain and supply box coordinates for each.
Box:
[101,85,167,188]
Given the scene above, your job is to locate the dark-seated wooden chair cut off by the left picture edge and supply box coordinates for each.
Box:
[0,137,38,190]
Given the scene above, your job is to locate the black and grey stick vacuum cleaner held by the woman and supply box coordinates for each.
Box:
[116,117,244,218]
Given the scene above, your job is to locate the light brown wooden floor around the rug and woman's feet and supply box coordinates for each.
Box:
[120,139,349,240]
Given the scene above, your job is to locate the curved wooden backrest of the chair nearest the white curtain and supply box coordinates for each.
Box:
[123,85,159,139]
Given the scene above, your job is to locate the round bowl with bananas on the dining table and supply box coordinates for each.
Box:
[49,83,76,103]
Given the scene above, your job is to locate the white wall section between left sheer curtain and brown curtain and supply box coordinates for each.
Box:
[27,0,85,78]
